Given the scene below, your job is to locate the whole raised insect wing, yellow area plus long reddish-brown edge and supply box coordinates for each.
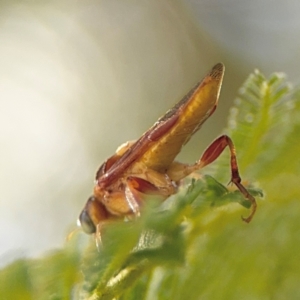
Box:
[97,63,225,188]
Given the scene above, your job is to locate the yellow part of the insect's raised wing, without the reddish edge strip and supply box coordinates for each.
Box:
[138,63,225,172]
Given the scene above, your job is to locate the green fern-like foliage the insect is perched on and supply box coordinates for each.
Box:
[0,71,300,300]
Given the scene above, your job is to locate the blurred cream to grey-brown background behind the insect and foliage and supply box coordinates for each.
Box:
[0,0,300,266]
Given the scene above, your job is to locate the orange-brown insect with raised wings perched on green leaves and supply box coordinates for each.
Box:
[79,63,256,234]
